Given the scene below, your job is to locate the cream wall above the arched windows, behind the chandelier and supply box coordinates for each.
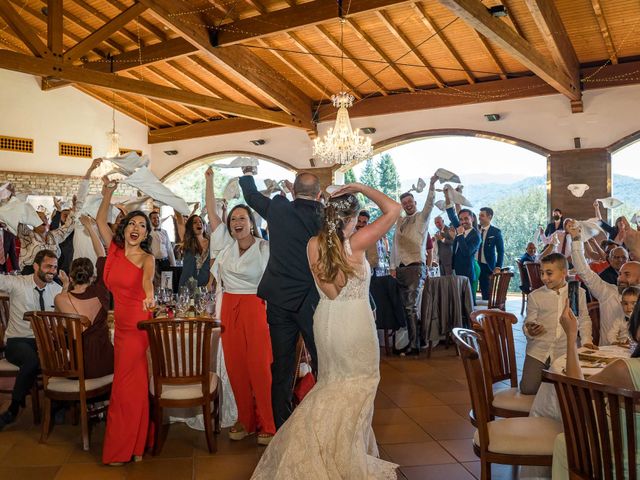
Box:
[150,85,640,176]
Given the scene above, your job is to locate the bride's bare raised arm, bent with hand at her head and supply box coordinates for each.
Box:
[332,183,402,253]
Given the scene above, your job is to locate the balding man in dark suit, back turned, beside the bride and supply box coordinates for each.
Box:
[240,173,322,428]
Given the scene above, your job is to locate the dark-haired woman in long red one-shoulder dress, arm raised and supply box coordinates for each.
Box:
[96,177,155,465]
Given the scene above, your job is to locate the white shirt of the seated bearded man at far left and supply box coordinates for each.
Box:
[0,275,62,338]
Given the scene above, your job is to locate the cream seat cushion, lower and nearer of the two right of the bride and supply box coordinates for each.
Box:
[473,417,563,455]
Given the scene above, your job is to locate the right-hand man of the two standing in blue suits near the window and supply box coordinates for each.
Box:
[478,207,504,300]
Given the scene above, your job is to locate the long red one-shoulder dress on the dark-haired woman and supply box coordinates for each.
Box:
[102,242,149,464]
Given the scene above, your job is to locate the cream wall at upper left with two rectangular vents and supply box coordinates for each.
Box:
[0,70,149,175]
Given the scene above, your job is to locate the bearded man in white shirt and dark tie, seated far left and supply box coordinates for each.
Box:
[0,249,63,430]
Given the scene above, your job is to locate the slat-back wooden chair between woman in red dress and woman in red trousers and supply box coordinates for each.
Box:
[138,317,222,455]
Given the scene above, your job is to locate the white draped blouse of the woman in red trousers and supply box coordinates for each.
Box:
[209,223,269,294]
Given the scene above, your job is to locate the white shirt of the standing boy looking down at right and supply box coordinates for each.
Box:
[522,284,593,363]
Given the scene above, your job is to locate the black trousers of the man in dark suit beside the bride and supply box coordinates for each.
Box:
[267,295,318,428]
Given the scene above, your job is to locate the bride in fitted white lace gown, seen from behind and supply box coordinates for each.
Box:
[251,183,401,480]
